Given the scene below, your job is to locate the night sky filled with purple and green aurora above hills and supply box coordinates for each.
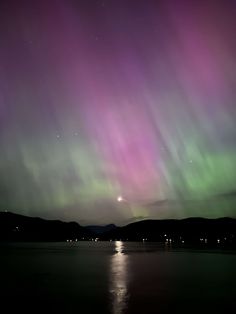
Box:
[0,0,236,225]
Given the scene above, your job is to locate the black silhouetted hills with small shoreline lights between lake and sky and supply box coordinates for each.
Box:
[0,212,236,248]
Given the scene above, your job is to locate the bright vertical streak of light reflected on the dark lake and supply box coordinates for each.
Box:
[110,241,128,314]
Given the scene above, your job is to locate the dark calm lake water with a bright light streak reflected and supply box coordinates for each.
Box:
[0,241,236,314]
